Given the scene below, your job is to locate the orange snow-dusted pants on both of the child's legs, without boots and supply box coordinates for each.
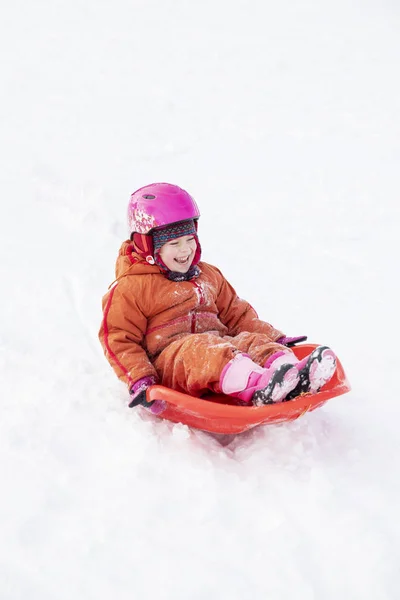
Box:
[154,331,287,396]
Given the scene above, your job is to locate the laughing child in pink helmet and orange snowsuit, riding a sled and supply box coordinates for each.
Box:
[99,183,336,412]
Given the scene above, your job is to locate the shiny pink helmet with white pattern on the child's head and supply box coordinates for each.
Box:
[128,183,200,237]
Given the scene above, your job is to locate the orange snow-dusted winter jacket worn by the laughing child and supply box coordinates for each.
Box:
[99,241,283,387]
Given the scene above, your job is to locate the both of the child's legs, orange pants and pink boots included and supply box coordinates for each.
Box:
[154,333,336,405]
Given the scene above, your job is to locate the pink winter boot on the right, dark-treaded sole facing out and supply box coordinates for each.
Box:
[286,346,336,400]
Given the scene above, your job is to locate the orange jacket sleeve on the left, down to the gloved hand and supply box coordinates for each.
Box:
[99,284,158,388]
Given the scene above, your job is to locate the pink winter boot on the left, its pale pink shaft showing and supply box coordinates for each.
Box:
[220,352,299,406]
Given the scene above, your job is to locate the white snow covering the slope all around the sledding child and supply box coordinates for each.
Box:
[0,0,400,600]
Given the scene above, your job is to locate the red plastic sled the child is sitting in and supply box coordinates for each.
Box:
[147,344,351,434]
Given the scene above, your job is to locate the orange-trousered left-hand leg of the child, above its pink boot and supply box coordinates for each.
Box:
[154,333,238,396]
